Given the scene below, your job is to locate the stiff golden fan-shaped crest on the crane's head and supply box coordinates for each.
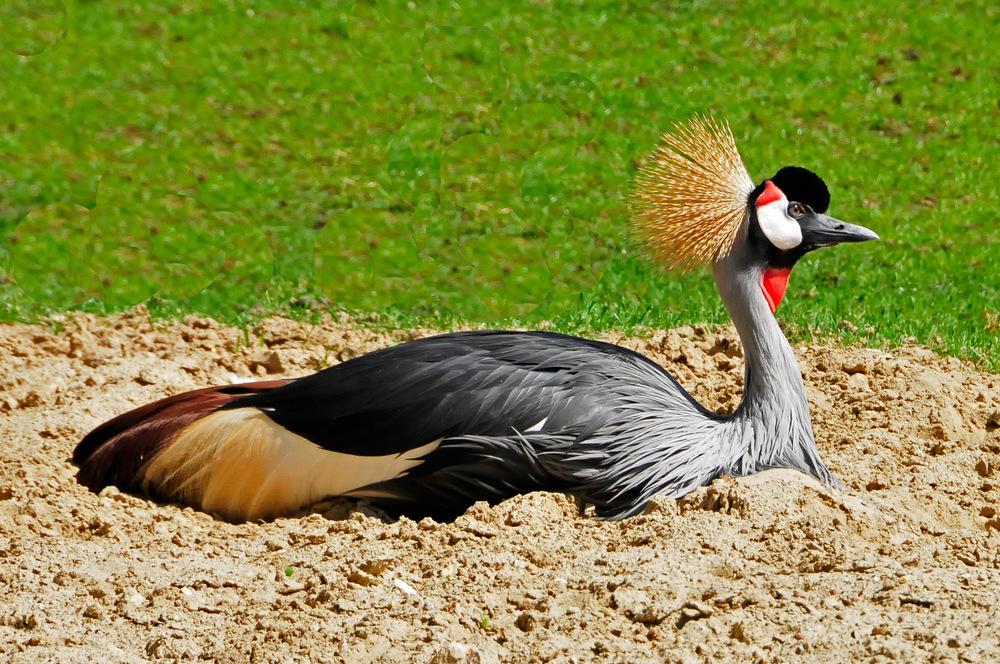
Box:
[632,117,754,270]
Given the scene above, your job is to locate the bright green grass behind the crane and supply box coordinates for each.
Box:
[0,0,1000,370]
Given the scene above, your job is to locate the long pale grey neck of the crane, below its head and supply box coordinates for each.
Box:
[714,246,838,484]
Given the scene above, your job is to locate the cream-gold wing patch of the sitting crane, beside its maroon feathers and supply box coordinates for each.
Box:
[139,408,441,521]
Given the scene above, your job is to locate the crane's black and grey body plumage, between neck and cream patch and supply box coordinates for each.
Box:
[232,331,719,516]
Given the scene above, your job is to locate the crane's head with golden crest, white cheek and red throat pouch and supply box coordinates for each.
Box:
[633,118,878,312]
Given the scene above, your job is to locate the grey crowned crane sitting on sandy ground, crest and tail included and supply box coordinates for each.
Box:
[73,118,878,521]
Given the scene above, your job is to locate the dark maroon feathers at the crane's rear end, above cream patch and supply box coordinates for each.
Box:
[73,380,291,492]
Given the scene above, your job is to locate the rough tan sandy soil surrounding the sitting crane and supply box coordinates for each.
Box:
[0,309,1000,664]
